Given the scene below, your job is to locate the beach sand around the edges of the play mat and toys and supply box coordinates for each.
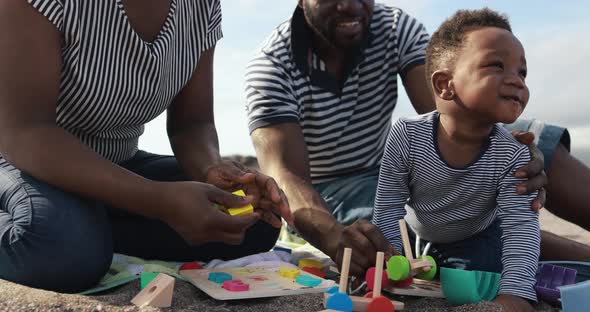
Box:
[0,211,590,312]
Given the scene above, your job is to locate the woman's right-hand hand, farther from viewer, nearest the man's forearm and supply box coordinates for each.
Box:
[206,160,293,228]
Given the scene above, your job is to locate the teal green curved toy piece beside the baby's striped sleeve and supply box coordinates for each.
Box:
[440,268,502,305]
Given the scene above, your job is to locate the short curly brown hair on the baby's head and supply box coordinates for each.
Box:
[426,8,512,86]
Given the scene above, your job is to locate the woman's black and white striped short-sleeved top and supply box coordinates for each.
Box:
[28,0,222,163]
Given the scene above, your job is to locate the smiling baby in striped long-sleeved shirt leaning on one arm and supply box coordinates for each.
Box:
[373,9,540,307]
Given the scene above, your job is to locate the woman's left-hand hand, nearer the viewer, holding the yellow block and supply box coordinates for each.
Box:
[156,182,260,245]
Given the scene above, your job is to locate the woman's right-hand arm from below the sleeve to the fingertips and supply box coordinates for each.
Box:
[167,47,292,227]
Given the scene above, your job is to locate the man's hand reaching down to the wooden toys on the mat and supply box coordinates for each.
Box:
[328,220,397,276]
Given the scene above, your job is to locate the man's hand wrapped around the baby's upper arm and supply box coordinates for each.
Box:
[512,130,547,211]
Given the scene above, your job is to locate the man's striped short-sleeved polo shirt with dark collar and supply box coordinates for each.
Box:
[246,4,428,183]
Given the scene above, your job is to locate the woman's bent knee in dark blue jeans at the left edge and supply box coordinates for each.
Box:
[0,179,113,292]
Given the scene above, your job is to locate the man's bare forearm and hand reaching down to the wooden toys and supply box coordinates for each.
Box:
[252,123,394,275]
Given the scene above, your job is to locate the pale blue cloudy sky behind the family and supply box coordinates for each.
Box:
[140,0,590,166]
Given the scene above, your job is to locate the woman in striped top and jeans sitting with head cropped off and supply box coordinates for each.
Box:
[0,0,290,292]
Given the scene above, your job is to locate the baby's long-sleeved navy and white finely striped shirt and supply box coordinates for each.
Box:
[373,112,540,300]
